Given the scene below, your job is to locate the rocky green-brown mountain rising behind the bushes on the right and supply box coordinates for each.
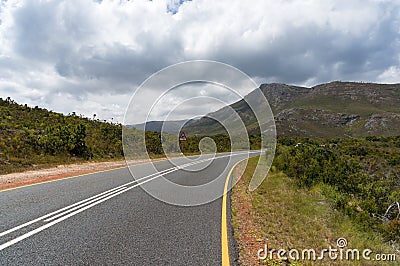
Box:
[184,81,400,137]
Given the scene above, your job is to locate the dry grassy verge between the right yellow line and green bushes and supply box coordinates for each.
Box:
[231,158,400,265]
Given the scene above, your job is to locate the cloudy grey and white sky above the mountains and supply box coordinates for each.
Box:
[0,0,400,122]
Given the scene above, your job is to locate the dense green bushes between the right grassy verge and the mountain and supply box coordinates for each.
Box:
[274,136,400,242]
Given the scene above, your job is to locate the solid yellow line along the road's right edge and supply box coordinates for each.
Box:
[221,158,247,266]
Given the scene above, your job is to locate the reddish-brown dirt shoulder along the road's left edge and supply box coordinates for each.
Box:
[0,159,162,190]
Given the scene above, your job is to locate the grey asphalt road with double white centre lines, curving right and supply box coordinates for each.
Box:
[0,153,254,265]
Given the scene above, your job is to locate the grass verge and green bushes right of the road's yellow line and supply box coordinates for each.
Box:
[232,136,400,265]
